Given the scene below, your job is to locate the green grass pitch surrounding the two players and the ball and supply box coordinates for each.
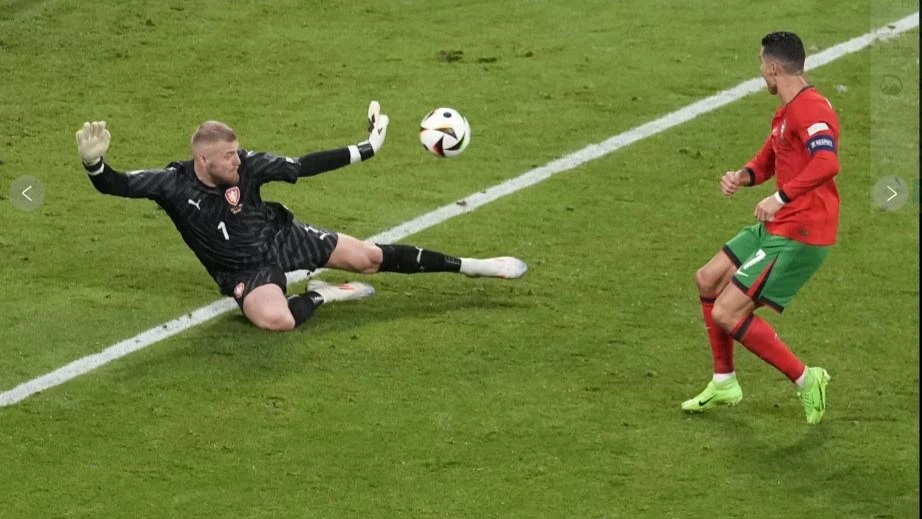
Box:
[0,0,919,519]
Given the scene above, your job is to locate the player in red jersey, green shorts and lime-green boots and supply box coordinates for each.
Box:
[682,32,839,424]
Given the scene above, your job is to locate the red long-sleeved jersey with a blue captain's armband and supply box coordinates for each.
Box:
[746,86,839,245]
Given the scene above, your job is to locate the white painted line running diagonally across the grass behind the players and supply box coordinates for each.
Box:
[0,12,919,407]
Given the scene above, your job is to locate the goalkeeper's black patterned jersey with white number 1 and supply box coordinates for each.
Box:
[90,150,302,275]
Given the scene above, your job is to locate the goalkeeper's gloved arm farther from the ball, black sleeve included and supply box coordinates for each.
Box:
[76,121,173,200]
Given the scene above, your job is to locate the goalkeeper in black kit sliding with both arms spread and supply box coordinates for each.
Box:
[77,101,527,331]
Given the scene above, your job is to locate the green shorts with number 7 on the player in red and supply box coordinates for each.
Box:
[723,223,830,313]
